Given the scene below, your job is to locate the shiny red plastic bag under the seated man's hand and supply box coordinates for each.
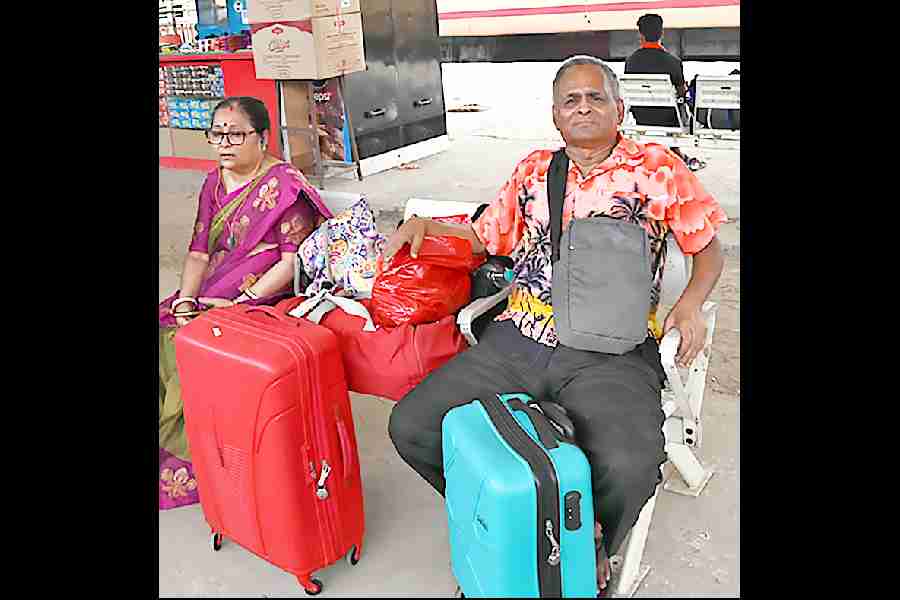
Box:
[370,235,485,327]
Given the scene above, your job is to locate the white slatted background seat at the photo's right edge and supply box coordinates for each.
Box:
[693,75,741,150]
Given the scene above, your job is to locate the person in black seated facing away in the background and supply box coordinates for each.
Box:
[625,14,706,171]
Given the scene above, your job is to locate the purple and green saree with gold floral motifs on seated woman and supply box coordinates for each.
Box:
[159,157,332,510]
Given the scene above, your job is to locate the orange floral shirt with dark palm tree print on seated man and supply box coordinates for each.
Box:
[472,135,727,347]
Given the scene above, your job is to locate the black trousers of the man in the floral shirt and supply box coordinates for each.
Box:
[388,321,666,555]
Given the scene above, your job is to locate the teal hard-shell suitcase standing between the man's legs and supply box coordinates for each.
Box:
[442,394,598,598]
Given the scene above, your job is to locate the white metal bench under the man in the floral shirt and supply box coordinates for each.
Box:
[319,191,717,597]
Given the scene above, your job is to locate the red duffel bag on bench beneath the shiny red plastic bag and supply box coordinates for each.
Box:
[275,297,469,402]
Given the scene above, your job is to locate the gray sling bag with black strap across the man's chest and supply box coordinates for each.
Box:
[547,149,652,354]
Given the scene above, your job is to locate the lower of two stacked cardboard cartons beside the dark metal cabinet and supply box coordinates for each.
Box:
[250,13,366,79]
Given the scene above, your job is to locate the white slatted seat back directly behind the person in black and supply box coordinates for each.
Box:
[619,73,696,147]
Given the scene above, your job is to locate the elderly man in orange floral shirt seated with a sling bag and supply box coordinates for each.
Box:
[385,56,726,589]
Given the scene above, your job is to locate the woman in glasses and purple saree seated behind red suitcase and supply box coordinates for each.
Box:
[159,97,331,509]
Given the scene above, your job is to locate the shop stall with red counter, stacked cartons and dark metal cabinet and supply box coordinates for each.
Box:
[159,0,449,183]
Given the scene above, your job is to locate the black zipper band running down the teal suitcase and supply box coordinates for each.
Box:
[479,395,562,598]
